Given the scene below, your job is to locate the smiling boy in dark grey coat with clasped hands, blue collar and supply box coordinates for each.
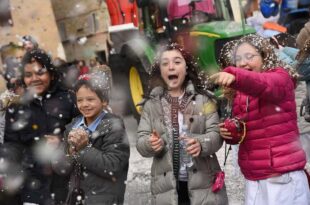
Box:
[54,72,129,205]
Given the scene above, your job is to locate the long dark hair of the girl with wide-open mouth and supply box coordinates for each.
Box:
[147,43,206,95]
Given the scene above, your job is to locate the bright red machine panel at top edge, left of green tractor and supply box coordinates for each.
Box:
[106,0,139,26]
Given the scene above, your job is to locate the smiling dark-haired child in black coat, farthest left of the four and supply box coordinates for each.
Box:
[1,49,78,205]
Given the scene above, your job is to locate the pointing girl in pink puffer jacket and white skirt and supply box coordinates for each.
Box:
[211,35,310,205]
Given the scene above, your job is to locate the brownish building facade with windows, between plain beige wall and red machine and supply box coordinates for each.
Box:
[52,0,110,62]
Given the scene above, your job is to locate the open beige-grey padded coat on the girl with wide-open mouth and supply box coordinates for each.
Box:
[136,83,228,205]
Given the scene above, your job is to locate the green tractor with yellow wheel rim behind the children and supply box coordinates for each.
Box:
[109,0,255,119]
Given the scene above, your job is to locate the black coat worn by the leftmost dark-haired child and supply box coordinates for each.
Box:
[1,84,78,204]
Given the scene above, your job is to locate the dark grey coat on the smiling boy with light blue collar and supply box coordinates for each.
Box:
[53,113,130,205]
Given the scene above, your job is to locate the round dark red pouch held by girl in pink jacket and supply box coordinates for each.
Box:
[224,118,246,144]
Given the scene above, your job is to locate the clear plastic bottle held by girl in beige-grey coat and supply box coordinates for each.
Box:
[180,124,194,167]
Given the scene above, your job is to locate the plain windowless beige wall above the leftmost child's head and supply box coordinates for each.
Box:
[0,0,64,58]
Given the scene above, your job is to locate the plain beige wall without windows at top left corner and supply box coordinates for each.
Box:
[0,0,65,90]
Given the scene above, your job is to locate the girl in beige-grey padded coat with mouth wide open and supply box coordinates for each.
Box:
[136,43,228,205]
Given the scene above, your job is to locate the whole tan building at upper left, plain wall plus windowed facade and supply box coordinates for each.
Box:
[0,0,110,91]
